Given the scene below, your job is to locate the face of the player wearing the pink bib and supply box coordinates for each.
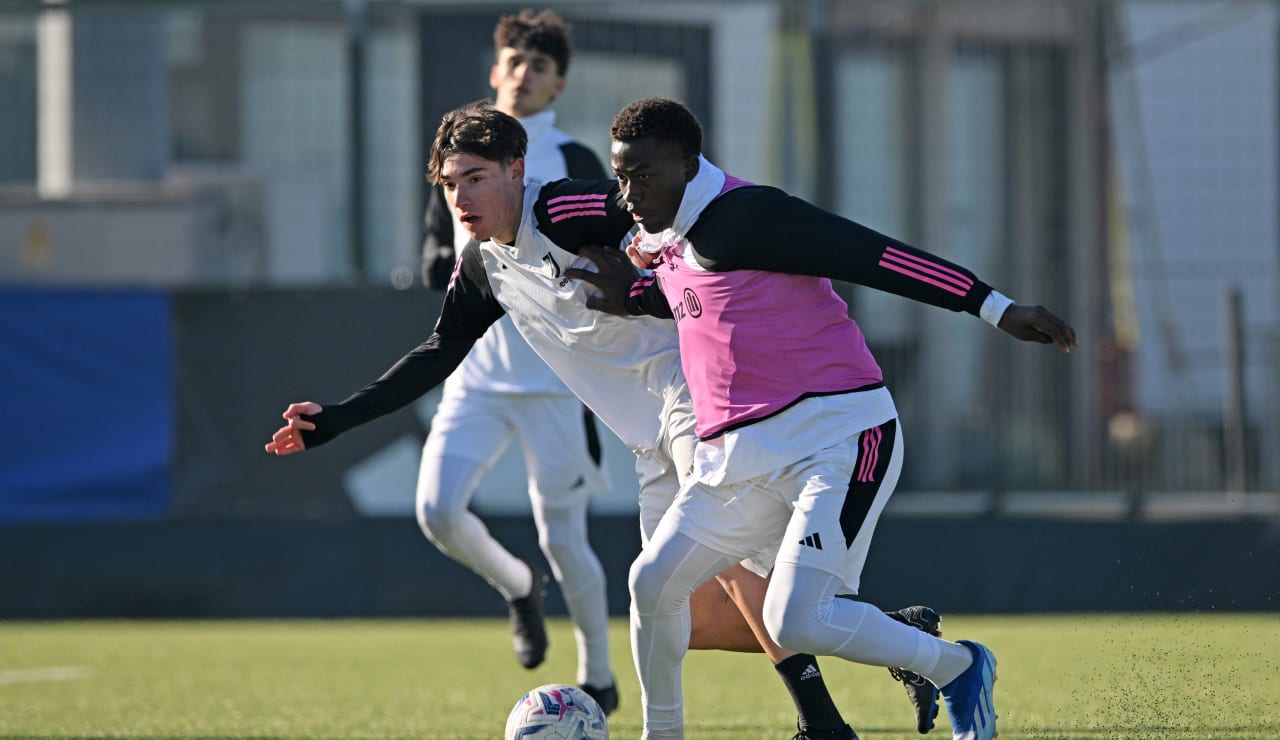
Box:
[609,137,698,234]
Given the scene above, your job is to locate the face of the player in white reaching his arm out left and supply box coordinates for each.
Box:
[440,154,525,245]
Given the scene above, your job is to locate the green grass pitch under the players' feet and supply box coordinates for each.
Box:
[0,615,1280,740]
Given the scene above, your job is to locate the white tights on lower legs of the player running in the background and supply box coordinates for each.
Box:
[416,454,613,686]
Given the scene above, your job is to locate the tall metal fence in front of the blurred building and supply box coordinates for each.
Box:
[0,0,1280,493]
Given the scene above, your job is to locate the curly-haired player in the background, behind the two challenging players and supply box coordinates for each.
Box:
[415,10,618,714]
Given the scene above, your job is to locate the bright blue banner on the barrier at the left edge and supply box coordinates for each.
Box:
[0,291,174,522]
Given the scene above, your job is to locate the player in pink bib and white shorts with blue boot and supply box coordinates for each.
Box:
[568,99,1076,740]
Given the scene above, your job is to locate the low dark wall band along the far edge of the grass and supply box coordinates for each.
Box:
[0,515,1280,620]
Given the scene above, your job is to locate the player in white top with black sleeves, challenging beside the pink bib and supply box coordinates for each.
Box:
[266,105,942,740]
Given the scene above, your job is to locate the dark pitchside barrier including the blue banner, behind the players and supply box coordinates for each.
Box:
[0,288,1280,618]
